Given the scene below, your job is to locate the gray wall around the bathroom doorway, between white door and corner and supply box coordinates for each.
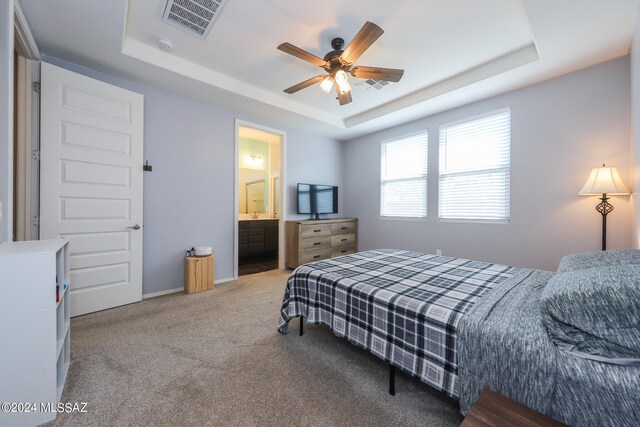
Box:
[45,57,343,294]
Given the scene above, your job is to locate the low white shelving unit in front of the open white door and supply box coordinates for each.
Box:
[0,240,71,426]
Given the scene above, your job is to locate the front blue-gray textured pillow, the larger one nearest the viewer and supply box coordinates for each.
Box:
[540,265,640,358]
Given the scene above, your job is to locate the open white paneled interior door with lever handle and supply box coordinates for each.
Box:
[40,63,144,316]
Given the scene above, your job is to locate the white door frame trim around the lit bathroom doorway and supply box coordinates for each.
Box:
[233,119,287,280]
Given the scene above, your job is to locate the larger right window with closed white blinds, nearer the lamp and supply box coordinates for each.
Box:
[438,109,511,221]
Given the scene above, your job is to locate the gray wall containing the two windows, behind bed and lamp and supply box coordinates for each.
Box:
[344,57,631,270]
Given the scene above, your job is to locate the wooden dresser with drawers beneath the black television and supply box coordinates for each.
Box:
[285,218,358,268]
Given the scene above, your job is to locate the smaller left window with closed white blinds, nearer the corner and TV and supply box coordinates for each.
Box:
[380,132,428,218]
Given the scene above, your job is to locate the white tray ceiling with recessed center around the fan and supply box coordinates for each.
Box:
[20,0,640,139]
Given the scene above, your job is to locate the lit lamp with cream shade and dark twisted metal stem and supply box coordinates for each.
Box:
[578,164,630,251]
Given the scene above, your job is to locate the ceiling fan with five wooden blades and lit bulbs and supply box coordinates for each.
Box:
[278,21,404,105]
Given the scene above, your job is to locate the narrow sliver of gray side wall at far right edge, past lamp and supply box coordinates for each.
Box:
[629,8,640,248]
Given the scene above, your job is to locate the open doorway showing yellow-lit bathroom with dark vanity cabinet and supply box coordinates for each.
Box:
[235,121,285,277]
